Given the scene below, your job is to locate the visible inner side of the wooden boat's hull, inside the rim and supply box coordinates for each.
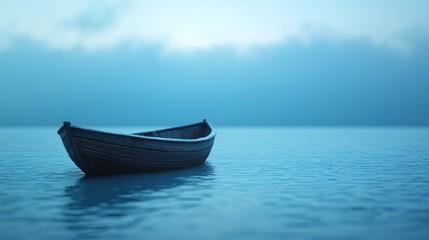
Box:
[135,122,211,139]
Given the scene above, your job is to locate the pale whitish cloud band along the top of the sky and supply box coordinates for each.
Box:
[0,0,429,52]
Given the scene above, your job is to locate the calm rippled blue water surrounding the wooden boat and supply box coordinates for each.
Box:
[0,128,429,239]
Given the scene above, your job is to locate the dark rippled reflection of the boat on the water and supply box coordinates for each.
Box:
[64,163,214,239]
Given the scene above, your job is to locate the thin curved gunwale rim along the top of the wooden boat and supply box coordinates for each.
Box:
[57,119,216,143]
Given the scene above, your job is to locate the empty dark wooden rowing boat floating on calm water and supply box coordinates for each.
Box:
[57,119,216,176]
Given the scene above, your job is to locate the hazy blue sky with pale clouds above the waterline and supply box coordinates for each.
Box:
[0,1,429,125]
